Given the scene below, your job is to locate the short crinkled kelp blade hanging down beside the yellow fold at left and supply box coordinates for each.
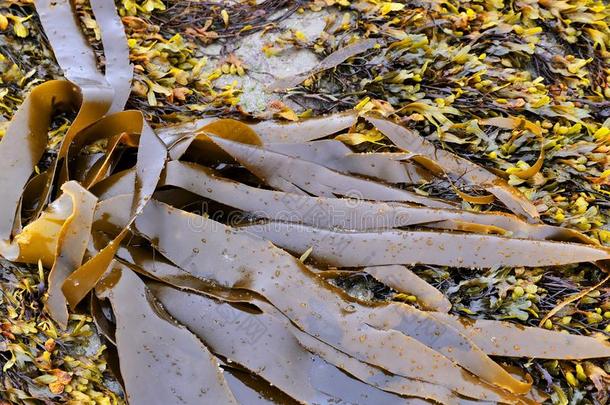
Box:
[44,181,97,328]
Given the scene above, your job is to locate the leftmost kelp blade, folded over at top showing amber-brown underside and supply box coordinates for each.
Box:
[0,80,81,249]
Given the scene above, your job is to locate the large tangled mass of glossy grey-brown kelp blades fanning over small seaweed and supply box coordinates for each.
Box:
[0,0,610,404]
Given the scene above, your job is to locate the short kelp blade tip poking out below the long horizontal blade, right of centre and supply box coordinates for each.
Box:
[363,265,451,312]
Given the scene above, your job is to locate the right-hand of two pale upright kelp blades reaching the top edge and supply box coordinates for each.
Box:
[88,0,133,113]
